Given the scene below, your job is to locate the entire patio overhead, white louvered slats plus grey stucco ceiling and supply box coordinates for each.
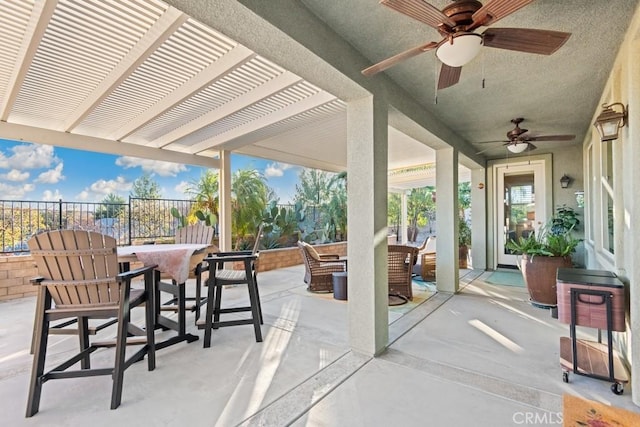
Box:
[0,0,638,187]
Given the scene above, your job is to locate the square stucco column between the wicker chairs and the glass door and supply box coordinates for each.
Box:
[436,148,460,293]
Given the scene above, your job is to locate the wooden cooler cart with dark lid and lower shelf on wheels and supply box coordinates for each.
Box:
[556,268,629,394]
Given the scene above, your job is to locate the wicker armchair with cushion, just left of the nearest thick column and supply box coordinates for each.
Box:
[298,241,347,292]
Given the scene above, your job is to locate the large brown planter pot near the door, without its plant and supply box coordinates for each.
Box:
[520,255,573,307]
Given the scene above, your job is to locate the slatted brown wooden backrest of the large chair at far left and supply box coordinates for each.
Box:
[28,230,120,308]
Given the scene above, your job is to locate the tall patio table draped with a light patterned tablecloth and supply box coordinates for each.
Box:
[118,243,209,349]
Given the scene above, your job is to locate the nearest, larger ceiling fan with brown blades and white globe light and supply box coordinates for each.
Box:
[362,0,571,89]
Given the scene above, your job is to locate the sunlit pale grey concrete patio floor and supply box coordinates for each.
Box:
[0,266,640,427]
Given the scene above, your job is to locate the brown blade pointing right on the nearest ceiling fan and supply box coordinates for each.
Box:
[483,28,571,55]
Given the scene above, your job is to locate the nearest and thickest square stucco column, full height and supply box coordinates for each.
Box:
[347,96,389,355]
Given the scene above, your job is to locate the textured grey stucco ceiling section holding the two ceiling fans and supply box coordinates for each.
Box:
[302,0,638,157]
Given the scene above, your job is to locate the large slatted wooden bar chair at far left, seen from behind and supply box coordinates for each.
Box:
[26,230,156,417]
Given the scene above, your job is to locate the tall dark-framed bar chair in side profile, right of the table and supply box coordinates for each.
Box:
[197,224,264,348]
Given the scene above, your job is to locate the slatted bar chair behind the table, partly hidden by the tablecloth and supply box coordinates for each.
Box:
[156,222,215,321]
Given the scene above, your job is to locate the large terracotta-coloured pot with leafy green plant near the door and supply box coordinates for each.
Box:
[506,206,580,307]
